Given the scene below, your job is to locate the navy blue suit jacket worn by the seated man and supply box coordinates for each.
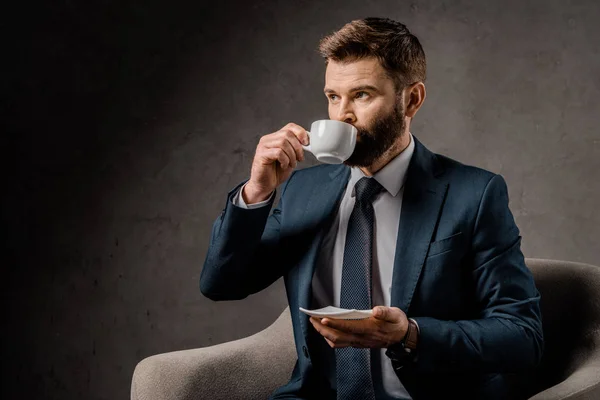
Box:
[200,138,543,399]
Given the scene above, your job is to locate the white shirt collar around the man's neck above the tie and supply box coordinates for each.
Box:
[349,132,415,197]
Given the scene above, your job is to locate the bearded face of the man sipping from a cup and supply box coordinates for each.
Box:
[325,58,406,167]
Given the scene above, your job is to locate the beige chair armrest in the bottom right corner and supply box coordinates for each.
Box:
[529,349,600,400]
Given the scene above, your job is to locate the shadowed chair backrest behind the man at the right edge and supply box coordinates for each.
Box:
[526,258,600,392]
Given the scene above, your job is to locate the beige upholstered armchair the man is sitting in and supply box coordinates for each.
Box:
[131,259,600,400]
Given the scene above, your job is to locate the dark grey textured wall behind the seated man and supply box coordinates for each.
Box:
[1,0,600,399]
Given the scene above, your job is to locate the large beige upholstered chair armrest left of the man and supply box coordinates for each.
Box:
[131,308,297,400]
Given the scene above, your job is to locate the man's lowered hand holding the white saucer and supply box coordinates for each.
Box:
[310,306,408,349]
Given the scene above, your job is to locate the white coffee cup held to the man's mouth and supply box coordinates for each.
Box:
[302,119,358,164]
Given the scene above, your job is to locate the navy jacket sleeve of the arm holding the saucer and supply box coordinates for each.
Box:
[413,175,543,372]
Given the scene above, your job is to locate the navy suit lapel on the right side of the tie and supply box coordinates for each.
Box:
[391,136,448,312]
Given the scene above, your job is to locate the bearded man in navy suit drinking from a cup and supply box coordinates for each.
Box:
[200,18,543,399]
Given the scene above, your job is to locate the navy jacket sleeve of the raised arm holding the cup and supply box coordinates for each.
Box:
[200,173,294,300]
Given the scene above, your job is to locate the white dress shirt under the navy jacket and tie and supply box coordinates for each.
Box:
[233,133,415,399]
